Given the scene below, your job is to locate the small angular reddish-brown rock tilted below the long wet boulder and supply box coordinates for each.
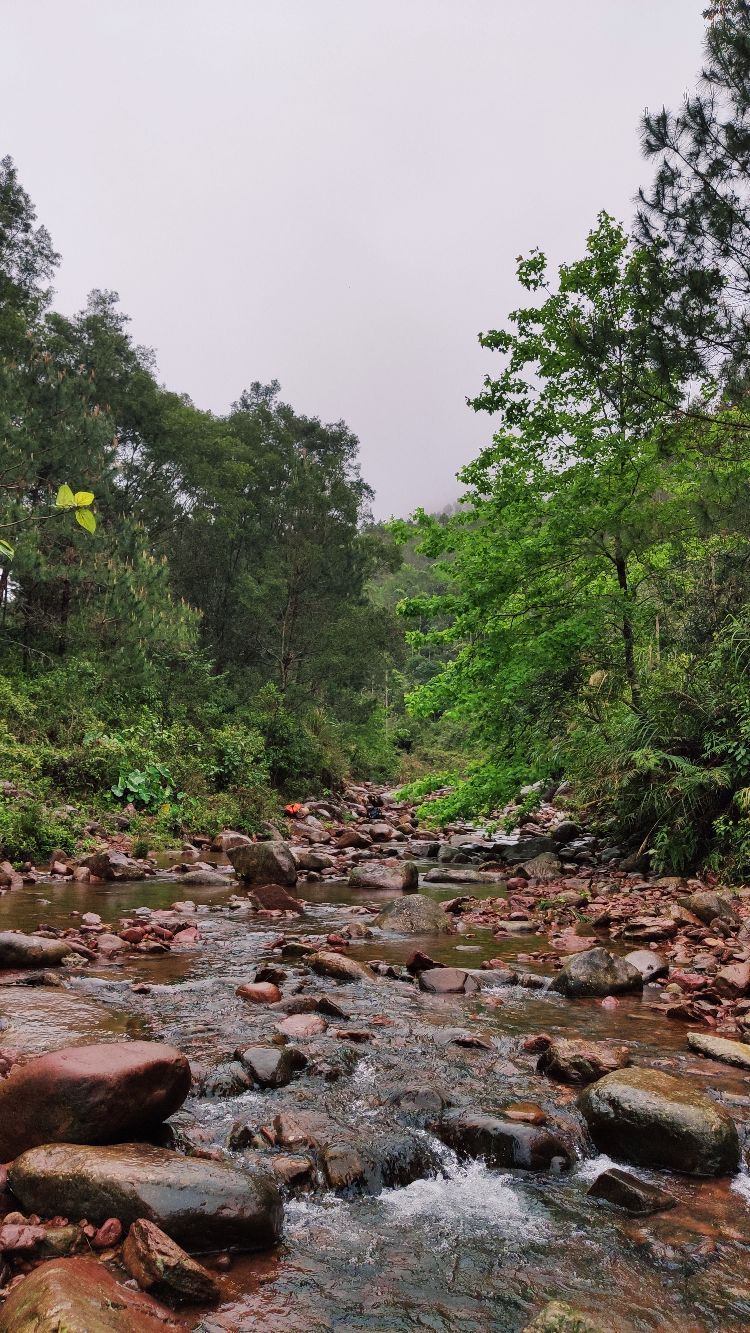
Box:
[123,1217,220,1305]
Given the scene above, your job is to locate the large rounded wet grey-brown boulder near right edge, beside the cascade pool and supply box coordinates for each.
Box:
[578,1066,739,1176]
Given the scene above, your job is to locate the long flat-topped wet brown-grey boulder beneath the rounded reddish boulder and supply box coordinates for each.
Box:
[8,1144,282,1250]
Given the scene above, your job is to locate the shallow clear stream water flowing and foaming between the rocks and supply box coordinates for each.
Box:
[0,880,750,1333]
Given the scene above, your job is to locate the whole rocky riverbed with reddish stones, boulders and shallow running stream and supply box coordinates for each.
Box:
[0,788,750,1333]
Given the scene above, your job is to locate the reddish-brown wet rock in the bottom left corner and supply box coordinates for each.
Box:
[0,1258,177,1333]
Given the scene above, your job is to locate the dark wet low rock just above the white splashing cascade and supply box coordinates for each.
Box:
[432,1110,570,1170]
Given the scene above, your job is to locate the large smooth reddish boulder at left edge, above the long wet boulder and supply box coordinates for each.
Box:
[0,1041,190,1161]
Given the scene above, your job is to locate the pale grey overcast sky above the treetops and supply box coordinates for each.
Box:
[0,0,706,516]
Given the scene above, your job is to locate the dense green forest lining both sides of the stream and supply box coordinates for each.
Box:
[0,0,750,876]
